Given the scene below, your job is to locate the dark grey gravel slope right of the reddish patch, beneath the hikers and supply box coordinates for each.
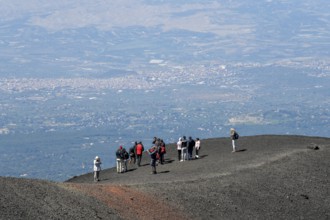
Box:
[69,135,330,219]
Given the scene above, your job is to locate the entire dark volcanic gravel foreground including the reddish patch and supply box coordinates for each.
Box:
[0,135,330,219]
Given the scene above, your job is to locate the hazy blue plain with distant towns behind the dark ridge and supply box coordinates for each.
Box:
[0,0,330,181]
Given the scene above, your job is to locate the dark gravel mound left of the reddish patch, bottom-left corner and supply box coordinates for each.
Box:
[0,178,119,220]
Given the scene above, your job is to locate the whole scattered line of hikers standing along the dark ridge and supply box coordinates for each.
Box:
[94,128,239,182]
